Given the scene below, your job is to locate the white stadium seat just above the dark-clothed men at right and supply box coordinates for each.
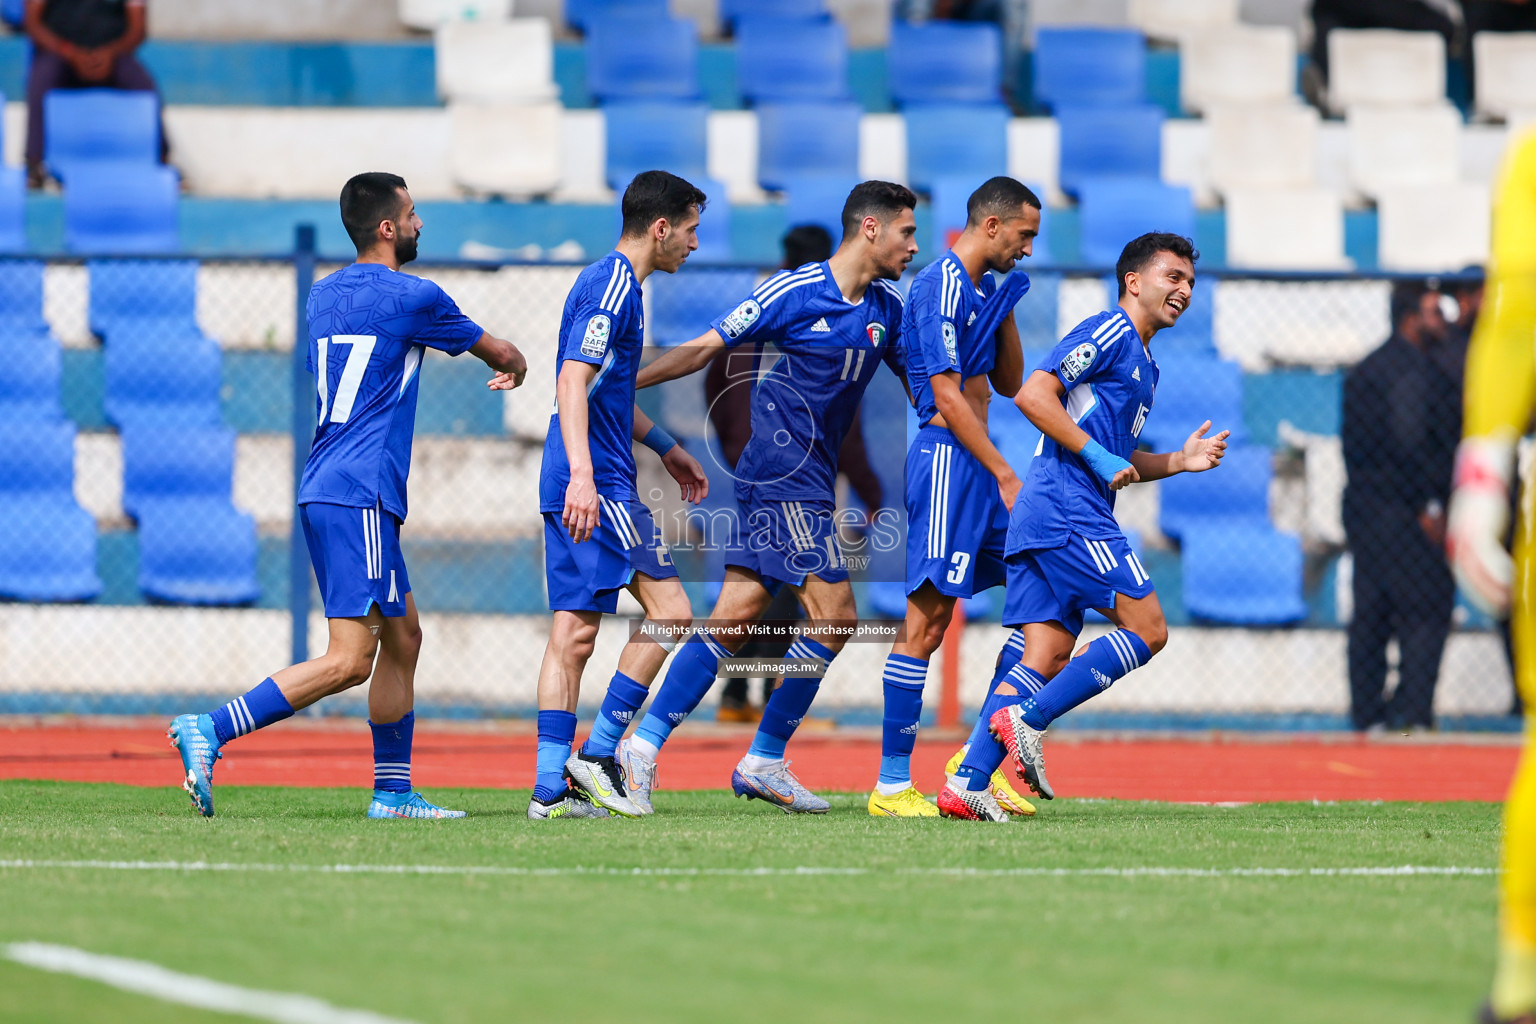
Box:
[1376,183,1491,273]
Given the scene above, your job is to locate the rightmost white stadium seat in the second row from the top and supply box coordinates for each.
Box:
[1344,103,1461,198]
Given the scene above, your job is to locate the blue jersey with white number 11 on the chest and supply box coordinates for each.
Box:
[710,263,902,500]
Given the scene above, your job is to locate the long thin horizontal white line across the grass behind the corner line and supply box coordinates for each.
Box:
[0,860,1499,878]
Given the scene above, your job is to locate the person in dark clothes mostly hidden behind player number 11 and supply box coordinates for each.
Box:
[703,224,883,722]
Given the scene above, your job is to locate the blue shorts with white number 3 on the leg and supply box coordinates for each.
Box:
[906,427,1008,597]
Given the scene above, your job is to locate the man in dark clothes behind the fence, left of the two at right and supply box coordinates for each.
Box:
[1342,282,1461,731]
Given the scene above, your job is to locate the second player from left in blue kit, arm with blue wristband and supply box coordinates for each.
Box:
[516,170,710,820]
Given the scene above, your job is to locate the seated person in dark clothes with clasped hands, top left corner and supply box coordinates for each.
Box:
[23,0,166,189]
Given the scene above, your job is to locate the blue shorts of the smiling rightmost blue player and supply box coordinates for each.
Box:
[1003,533,1152,634]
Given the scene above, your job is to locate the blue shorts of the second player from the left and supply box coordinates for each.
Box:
[544,494,677,614]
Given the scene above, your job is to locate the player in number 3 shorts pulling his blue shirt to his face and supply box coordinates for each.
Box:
[869,177,1040,818]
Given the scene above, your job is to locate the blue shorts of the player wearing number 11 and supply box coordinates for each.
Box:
[725,484,848,593]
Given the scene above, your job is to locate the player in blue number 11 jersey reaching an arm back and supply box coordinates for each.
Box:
[619,181,917,814]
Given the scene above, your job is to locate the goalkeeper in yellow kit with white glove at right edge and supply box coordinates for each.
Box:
[1447,130,1536,1024]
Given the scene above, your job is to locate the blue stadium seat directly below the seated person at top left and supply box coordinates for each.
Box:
[43,89,160,184]
